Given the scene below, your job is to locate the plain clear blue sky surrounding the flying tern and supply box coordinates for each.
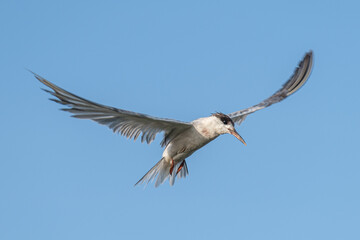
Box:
[0,0,360,240]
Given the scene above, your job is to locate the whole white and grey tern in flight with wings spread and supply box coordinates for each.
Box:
[31,51,313,187]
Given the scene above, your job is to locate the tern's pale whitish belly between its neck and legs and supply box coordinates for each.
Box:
[163,129,213,163]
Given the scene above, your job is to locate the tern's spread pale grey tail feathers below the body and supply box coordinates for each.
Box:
[135,158,189,187]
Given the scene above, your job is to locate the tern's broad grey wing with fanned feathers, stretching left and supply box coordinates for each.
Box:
[32,72,192,146]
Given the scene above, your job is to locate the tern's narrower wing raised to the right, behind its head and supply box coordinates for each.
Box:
[228,51,313,124]
